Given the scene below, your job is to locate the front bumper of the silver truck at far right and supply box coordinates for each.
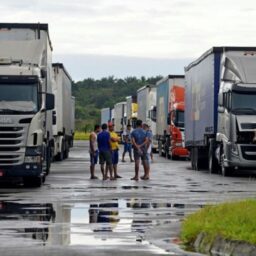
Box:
[224,144,256,170]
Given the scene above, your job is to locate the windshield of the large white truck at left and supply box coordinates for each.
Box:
[0,84,38,114]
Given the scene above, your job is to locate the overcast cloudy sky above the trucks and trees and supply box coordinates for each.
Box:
[0,0,256,81]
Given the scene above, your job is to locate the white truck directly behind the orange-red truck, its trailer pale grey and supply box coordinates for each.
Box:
[137,84,157,153]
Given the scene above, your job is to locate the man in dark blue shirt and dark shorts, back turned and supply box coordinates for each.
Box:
[97,124,114,180]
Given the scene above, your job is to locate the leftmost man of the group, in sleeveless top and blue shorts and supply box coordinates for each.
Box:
[89,124,100,179]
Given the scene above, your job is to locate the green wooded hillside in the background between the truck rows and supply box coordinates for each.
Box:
[72,76,162,132]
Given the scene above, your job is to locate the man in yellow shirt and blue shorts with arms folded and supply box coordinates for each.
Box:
[108,122,122,179]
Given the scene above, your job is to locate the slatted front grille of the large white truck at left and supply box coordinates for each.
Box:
[0,126,25,166]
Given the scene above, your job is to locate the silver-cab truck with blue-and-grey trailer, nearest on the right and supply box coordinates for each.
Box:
[185,47,256,176]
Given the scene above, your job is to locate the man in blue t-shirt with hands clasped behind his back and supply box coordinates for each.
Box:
[131,120,149,181]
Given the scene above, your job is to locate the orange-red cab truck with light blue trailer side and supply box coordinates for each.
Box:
[156,75,189,160]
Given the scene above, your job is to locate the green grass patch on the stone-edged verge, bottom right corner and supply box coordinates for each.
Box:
[181,199,256,245]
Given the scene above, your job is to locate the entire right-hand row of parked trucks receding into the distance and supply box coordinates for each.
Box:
[101,47,256,176]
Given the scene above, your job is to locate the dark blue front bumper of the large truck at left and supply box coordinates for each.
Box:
[0,163,43,179]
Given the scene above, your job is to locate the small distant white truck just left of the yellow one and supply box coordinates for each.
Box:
[114,101,127,135]
